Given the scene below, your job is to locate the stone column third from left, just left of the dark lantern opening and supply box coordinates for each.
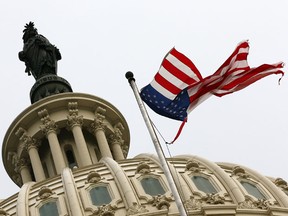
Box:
[38,109,66,174]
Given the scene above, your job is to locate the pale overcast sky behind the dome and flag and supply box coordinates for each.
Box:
[0,0,288,198]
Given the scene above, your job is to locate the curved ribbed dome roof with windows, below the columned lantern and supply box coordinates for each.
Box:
[0,153,288,216]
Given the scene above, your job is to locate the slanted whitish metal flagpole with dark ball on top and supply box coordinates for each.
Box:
[125,71,187,216]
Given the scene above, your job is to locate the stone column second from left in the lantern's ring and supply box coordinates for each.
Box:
[16,127,46,181]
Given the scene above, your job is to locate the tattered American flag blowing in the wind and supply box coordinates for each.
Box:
[140,41,284,121]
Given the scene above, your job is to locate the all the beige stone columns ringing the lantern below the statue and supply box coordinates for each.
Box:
[15,102,125,184]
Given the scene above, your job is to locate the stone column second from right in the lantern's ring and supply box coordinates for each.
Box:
[91,107,112,158]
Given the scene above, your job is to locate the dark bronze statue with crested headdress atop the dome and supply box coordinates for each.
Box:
[18,22,61,80]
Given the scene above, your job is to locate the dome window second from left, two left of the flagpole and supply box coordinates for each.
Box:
[89,186,112,206]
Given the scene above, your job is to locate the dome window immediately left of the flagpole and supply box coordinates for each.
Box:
[140,177,165,196]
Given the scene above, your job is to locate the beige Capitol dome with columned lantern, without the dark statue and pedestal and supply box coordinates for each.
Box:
[0,93,288,216]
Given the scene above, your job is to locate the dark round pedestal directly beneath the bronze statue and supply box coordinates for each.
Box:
[30,74,73,104]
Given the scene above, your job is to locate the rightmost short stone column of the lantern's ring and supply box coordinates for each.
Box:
[110,122,125,160]
